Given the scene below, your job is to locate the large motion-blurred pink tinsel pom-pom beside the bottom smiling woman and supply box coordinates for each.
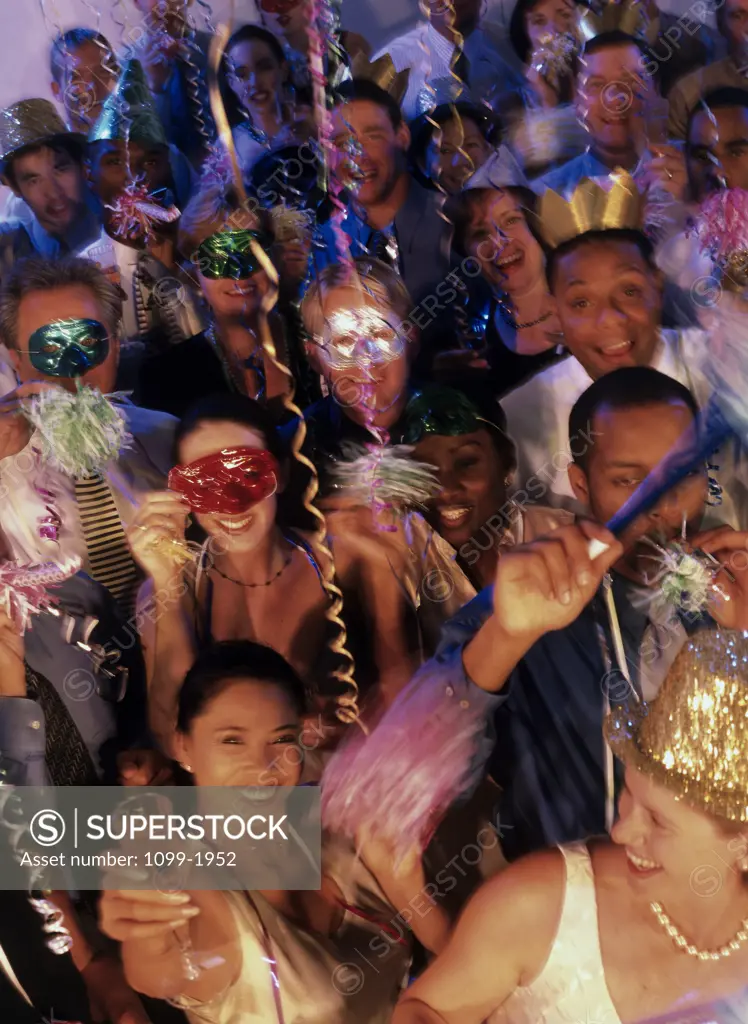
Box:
[322,663,497,862]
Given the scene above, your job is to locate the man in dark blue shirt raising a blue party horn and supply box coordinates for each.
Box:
[401,367,748,860]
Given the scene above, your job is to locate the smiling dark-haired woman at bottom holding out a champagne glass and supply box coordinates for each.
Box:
[99,640,447,1024]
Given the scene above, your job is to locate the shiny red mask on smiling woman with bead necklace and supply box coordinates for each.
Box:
[168,447,278,515]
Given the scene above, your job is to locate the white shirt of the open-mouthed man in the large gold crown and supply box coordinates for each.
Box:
[501,329,748,528]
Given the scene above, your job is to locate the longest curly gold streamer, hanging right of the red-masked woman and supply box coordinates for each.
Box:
[208,25,368,732]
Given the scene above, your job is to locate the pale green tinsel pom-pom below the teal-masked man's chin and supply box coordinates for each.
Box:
[24,386,131,478]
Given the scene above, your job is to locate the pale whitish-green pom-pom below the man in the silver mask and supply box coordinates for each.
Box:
[331,444,440,510]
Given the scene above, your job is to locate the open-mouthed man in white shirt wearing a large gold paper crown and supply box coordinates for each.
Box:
[502,173,748,528]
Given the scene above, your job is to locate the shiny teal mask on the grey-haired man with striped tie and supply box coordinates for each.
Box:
[29,319,110,377]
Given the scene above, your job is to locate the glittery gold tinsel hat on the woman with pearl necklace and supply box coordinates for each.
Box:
[605,630,748,821]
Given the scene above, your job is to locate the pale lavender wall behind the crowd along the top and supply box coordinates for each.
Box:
[0,0,418,106]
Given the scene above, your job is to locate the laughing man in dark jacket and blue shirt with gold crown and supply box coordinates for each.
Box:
[315,65,450,304]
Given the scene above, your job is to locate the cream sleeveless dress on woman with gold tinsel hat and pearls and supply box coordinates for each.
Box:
[488,843,621,1024]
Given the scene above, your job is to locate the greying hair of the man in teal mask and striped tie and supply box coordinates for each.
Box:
[0,256,122,348]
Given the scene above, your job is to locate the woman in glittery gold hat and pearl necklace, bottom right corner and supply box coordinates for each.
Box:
[393,630,748,1024]
